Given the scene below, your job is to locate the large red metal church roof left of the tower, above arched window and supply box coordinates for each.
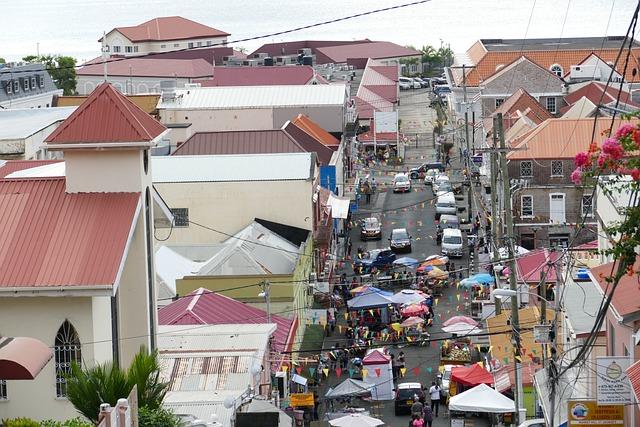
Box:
[0,178,140,288]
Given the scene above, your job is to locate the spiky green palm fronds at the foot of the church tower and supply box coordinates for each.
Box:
[66,347,169,423]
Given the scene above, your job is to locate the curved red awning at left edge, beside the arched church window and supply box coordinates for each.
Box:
[0,337,53,380]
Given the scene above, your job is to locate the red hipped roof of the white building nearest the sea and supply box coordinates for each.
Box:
[107,16,230,42]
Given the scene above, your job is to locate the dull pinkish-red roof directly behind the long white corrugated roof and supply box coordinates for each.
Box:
[196,65,326,87]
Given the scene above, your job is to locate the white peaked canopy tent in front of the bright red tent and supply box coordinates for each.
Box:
[449,384,516,414]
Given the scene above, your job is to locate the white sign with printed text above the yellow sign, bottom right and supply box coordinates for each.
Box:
[596,357,633,405]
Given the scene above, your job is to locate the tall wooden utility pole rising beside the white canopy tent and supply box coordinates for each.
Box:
[497,113,524,425]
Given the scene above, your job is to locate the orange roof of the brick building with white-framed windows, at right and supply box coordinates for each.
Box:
[507,117,638,160]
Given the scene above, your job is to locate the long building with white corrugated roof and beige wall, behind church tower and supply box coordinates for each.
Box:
[158,85,349,133]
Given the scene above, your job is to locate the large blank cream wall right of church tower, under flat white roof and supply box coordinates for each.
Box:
[155,180,313,244]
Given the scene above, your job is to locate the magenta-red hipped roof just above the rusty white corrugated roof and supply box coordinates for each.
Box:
[158,288,295,352]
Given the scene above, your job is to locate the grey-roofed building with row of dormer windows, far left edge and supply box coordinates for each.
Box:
[0,64,63,110]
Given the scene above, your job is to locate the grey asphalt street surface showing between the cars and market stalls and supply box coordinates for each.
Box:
[324,90,482,427]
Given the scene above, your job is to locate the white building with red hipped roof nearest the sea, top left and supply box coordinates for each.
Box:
[98,16,230,56]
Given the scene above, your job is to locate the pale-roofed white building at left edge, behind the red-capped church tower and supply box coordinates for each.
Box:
[0,107,76,160]
